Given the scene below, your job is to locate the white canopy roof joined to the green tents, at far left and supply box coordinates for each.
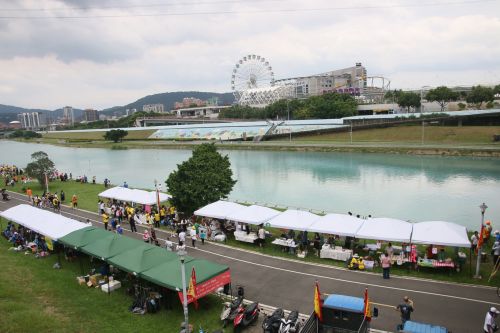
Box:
[0,204,88,240]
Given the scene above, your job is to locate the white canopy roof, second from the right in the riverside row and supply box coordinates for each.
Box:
[356,217,412,243]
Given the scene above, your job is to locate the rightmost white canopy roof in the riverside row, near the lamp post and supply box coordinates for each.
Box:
[411,221,471,248]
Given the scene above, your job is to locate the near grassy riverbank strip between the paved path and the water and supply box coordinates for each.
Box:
[4,181,500,286]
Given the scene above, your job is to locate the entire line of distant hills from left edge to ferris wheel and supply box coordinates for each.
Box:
[0,91,234,123]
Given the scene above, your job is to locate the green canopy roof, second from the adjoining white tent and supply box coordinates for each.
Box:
[80,234,144,260]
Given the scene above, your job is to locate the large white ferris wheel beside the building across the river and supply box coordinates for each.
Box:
[231,54,274,99]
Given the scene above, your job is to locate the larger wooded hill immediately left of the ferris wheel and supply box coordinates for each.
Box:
[101,91,234,116]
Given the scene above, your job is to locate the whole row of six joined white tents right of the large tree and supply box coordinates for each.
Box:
[194,200,471,248]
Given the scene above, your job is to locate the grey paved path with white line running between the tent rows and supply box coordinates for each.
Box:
[0,193,500,333]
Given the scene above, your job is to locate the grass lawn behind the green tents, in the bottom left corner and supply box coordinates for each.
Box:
[0,233,222,333]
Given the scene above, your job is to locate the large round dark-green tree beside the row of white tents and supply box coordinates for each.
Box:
[165,143,236,216]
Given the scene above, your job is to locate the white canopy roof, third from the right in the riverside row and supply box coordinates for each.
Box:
[307,214,365,237]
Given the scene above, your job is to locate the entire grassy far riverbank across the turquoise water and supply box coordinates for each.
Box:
[19,125,492,157]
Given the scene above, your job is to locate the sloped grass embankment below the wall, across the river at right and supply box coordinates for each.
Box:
[280,125,500,144]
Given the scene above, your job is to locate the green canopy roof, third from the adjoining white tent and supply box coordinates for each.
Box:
[108,244,178,275]
